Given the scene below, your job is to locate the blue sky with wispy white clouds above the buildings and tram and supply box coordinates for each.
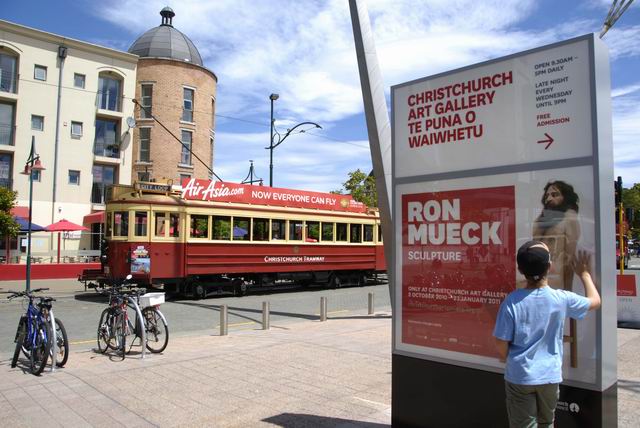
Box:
[0,0,640,192]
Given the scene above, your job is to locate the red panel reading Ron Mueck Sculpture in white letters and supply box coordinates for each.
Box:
[402,186,516,357]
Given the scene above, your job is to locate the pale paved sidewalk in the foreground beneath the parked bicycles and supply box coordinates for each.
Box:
[0,312,640,428]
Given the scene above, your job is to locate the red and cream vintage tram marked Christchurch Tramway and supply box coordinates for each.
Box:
[102,179,386,298]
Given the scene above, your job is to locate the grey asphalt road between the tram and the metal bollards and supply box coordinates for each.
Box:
[0,283,390,356]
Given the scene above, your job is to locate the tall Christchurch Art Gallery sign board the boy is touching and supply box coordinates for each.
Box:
[391,35,617,427]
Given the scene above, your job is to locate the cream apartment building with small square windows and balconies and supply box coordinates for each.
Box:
[0,20,138,254]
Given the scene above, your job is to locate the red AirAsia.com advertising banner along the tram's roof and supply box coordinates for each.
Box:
[182,178,367,213]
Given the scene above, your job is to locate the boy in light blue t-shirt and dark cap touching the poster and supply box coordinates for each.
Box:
[493,241,600,428]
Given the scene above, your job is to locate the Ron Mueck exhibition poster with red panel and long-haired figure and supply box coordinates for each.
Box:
[395,167,597,382]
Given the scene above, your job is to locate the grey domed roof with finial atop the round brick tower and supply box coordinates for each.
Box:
[129,7,203,66]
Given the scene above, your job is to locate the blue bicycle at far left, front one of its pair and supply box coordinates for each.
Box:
[7,288,52,375]
